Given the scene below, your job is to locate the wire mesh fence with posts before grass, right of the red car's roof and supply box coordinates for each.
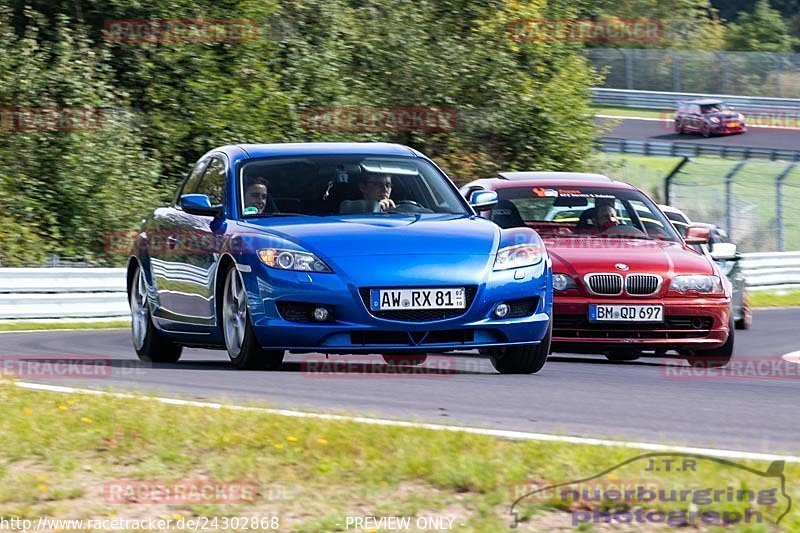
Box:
[666,159,800,252]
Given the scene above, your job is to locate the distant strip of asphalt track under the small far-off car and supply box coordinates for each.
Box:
[595,117,800,150]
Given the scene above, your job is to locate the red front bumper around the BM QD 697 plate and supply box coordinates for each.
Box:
[553,296,730,353]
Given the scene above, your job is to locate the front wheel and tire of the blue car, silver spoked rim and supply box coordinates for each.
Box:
[222,267,285,370]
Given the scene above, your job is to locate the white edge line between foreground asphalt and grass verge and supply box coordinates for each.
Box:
[14,381,800,463]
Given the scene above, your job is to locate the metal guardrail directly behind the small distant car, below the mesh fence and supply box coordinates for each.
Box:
[592,87,800,111]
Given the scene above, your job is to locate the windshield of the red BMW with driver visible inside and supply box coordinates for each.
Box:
[491,186,681,242]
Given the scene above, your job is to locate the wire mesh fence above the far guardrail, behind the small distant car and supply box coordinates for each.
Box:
[586,48,800,98]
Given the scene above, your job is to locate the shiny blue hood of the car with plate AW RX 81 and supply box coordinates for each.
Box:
[242,215,500,258]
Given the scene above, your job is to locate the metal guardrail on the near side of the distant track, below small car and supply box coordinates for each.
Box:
[597,137,800,161]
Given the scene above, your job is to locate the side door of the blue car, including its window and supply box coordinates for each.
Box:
[170,154,228,326]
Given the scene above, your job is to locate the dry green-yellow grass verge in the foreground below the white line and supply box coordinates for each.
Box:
[0,383,800,531]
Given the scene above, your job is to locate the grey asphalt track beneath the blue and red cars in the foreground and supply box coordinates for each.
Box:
[0,308,800,453]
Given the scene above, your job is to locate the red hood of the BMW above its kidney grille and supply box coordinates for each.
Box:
[544,238,714,279]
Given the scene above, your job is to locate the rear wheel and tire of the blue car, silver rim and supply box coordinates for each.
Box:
[128,266,183,363]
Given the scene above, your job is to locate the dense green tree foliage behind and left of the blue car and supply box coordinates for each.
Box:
[0,0,596,265]
